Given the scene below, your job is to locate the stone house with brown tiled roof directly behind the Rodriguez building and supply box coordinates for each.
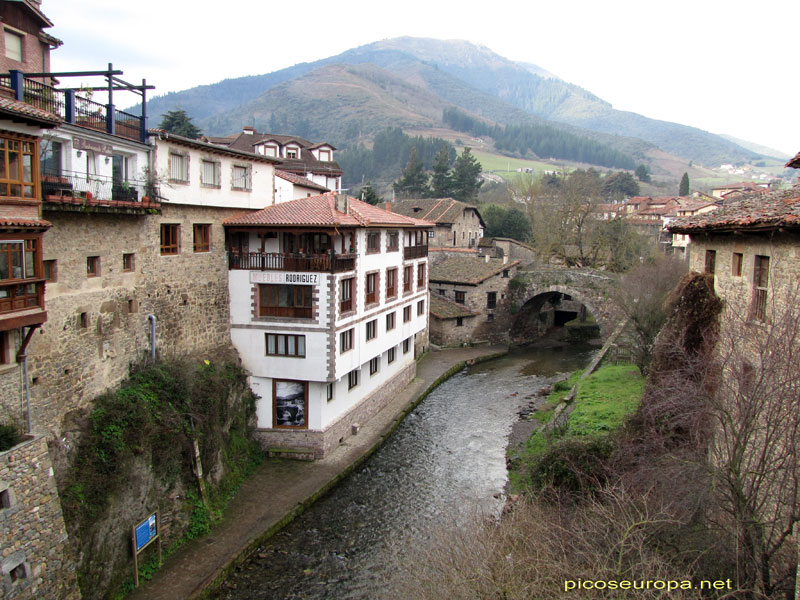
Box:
[382,198,486,248]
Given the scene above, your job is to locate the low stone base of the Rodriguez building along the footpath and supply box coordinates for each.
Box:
[255,361,417,458]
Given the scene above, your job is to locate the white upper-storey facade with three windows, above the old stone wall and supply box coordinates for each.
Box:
[151,133,279,210]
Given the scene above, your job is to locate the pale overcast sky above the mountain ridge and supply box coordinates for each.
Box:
[42,0,800,156]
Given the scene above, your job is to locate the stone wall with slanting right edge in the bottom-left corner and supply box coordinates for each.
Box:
[0,436,80,600]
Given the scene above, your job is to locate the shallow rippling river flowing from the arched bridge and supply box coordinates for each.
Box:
[214,346,595,600]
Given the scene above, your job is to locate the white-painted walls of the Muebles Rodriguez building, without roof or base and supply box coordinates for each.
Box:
[229,227,428,431]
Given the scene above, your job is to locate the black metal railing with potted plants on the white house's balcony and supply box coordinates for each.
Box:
[42,171,156,202]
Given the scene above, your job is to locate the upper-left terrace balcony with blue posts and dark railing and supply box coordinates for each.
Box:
[0,71,147,143]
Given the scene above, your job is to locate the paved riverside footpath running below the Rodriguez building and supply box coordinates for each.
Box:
[128,346,506,600]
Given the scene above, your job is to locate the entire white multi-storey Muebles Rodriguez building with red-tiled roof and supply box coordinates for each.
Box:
[225,193,432,457]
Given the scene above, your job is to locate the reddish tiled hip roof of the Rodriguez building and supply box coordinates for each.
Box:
[223,192,433,228]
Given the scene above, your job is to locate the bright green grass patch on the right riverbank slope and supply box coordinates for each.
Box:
[509,365,644,492]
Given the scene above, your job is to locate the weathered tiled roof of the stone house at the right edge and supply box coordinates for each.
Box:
[667,185,800,233]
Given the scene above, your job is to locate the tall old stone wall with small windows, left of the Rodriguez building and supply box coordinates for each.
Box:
[28,204,241,437]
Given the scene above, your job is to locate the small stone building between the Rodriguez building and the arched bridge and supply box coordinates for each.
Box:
[430,255,519,346]
